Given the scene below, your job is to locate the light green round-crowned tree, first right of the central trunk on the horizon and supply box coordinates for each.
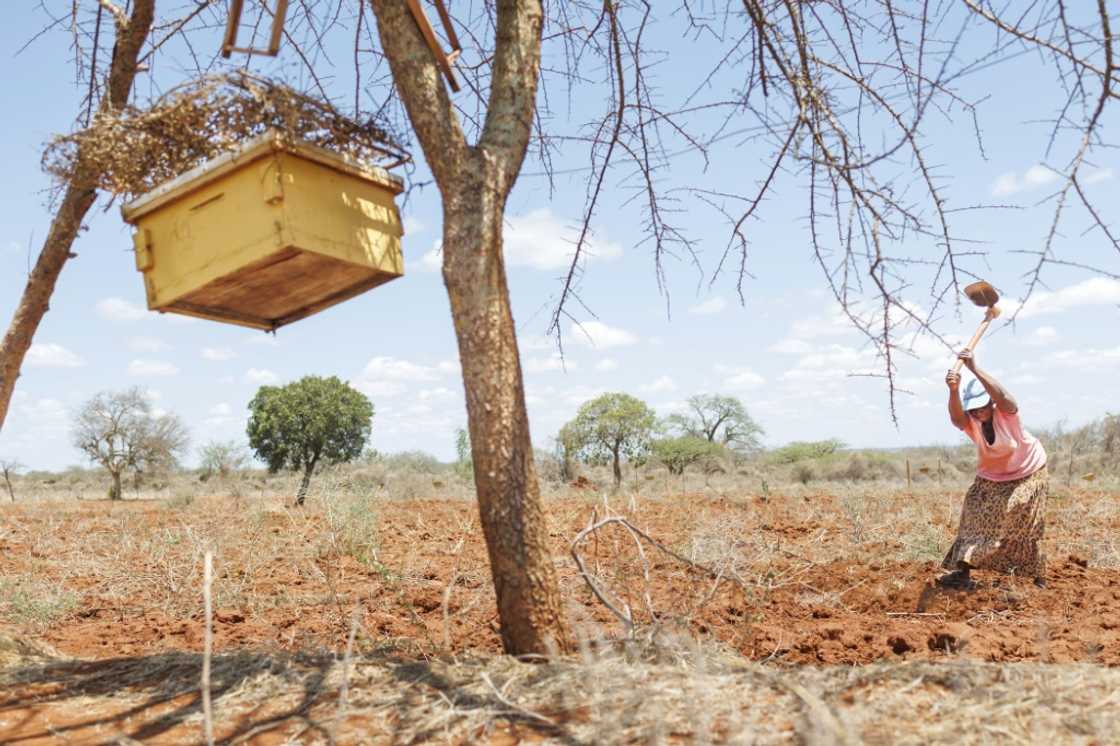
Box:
[564,393,657,489]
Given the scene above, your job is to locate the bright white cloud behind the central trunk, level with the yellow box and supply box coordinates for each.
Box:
[420,207,623,270]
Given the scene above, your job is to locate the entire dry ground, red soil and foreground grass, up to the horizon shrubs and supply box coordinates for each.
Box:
[0,484,1120,744]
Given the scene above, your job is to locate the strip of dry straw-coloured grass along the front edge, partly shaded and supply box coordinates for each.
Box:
[0,641,1120,746]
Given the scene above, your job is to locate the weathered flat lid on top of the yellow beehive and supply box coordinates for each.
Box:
[121,130,404,223]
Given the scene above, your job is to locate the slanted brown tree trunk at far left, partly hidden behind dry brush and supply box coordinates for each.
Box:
[0,0,155,429]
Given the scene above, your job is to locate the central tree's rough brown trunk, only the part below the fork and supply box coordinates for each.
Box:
[444,184,568,654]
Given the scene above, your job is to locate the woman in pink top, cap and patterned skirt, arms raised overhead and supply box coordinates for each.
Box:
[937,349,1048,588]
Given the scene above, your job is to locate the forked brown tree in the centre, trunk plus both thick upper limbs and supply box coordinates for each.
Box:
[373,0,570,655]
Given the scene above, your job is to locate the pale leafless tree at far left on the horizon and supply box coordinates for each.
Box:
[71,388,189,500]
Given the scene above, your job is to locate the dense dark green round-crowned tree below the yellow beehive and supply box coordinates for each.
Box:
[248,375,373,505]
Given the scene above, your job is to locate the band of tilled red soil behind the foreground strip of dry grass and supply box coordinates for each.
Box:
[0,496,1120,665]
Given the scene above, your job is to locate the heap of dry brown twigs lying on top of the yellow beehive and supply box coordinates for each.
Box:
[43,72,409,197]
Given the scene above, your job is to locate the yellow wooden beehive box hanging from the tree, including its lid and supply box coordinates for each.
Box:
[121,132,404,329]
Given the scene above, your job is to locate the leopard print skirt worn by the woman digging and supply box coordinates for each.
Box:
[941,466,1049,578]
